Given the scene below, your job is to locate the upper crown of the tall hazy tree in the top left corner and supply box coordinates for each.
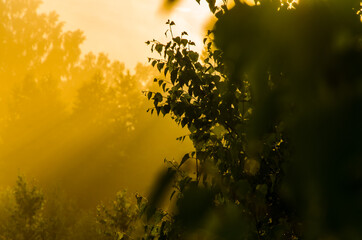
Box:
[0,0,84,91]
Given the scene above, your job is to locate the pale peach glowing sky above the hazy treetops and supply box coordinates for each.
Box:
[40,0,215,69]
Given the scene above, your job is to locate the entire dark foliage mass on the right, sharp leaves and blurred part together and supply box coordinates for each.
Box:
[146,0,362,239]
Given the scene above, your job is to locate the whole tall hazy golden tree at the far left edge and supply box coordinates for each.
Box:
[0,0,84,162]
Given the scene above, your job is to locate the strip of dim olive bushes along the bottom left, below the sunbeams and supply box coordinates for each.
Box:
[0,177,171,240]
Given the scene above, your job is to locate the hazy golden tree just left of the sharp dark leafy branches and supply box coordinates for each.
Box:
[70,53,147,132]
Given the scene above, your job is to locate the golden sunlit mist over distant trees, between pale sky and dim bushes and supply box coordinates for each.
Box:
[0,1,192,207]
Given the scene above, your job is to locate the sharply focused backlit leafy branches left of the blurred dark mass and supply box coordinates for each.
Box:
[147,19,297,239]
